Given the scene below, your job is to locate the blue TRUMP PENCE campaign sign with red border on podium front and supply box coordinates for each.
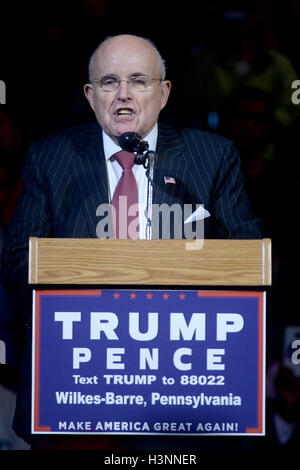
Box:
[32,289,265,435]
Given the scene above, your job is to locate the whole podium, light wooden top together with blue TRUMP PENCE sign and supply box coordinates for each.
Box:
[29,238,271,436]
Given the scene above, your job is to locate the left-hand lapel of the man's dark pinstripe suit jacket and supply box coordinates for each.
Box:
[72,123,108,237]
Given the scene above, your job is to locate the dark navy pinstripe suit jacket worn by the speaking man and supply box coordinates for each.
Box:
[1,123,262,441]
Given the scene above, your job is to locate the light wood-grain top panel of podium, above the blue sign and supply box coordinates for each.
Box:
[29,238,271,287]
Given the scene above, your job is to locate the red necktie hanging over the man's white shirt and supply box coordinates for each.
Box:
[112,150,139,238]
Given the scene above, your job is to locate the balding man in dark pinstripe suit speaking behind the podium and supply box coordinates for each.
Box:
[1,35,262,441]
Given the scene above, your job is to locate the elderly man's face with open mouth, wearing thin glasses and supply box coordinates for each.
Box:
[85,35,171,143]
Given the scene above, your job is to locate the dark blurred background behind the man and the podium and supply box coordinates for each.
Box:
[0,0,300,448]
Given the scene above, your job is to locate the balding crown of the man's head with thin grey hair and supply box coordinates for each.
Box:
[89,34,166,83]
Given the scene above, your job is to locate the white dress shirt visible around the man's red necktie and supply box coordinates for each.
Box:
[102,124,158,239]
